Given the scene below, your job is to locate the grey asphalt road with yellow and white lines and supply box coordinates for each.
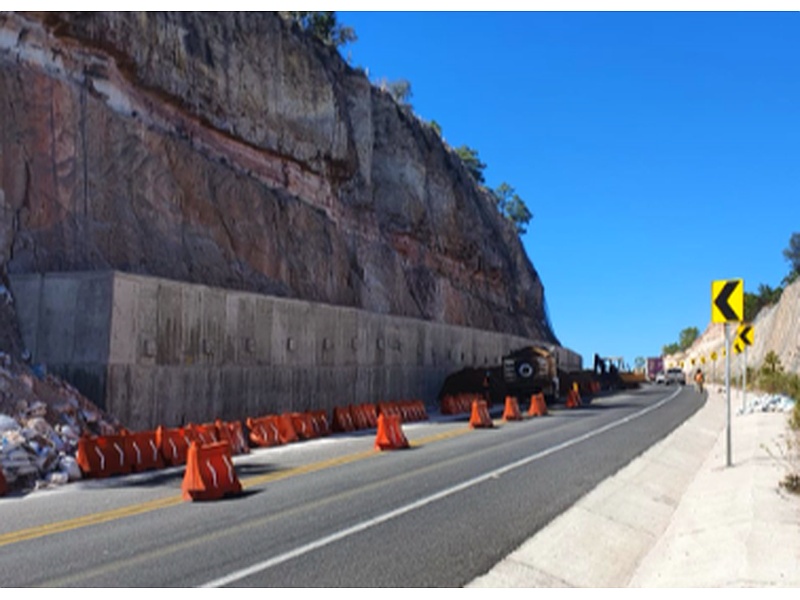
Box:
[0,386,702,587]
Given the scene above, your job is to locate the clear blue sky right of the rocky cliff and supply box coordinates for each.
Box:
[338,12,800,365]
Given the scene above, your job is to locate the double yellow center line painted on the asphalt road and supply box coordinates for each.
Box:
[0,428,471,547]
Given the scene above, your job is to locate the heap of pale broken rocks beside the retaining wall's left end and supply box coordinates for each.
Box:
[0,353,121,490]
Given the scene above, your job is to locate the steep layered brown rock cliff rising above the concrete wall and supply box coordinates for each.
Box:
[0,13,556,356]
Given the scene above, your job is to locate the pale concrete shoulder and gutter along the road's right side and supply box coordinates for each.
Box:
[467,386,800,588]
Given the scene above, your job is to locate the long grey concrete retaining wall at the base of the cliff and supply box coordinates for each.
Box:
[11,271,581,430]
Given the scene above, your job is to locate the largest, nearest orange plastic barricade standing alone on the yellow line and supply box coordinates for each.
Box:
[181,442,242,500]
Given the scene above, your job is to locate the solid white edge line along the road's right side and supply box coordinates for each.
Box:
[198,387,683,588]
